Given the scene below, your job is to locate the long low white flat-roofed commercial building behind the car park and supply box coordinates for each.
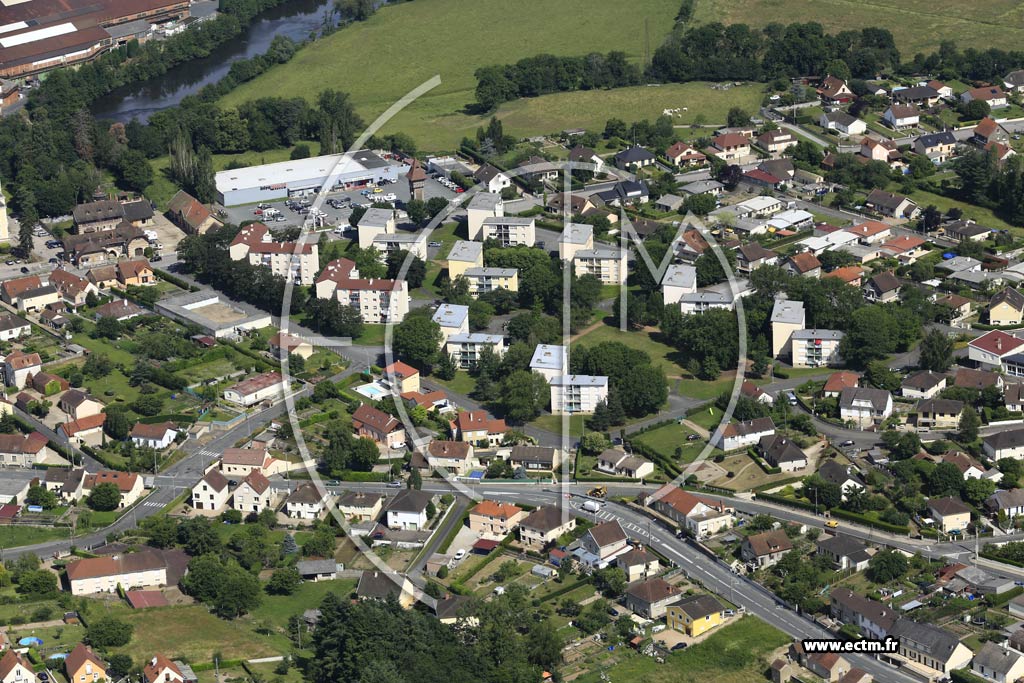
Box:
[216,150,409,207]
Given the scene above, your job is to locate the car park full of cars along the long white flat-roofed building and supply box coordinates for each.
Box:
[225,178,456,228]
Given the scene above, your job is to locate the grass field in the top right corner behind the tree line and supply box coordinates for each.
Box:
[694,0,1024,58]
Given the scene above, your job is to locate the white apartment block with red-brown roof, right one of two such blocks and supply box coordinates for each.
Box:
[316,258,409,325]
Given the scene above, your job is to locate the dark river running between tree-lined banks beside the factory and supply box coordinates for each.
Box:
[92,0,333,122]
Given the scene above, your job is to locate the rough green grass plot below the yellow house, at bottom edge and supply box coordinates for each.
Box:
[575,616,790,683]
